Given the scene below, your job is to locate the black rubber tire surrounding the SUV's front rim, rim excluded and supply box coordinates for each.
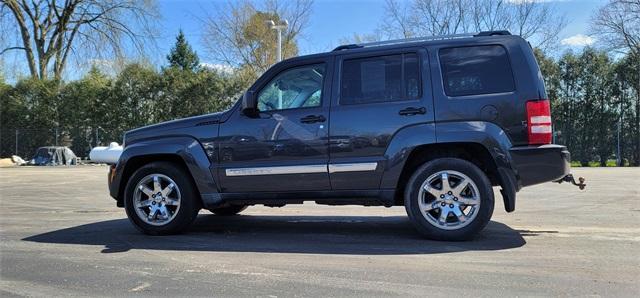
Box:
[124,162,200,235]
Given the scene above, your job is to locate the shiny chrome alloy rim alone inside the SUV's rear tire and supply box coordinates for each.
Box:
[418,170,480,230]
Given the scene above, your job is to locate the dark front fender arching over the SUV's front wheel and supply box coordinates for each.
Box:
[109,136,218,205]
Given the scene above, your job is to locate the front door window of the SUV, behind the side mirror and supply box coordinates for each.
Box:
[258,64,325,111]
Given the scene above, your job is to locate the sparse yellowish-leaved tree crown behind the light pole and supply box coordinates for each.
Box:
[203,0,312,76]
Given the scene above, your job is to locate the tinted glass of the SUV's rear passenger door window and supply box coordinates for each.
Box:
[340,54,420,104]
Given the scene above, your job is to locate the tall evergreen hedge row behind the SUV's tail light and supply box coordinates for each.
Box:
[536,47,640,166]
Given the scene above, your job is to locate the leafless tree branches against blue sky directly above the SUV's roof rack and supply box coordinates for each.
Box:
[380,0,566,49]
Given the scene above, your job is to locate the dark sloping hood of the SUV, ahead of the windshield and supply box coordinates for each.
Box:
[123,111,228,146]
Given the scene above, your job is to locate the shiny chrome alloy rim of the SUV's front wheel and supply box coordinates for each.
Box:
[133,174,181,226]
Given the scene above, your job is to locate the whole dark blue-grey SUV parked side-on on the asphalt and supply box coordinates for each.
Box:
[108,31,570,240]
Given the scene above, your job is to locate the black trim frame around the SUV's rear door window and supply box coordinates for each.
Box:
[337,49,424,106]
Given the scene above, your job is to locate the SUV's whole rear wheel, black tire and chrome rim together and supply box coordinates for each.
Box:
[404,158,494,241]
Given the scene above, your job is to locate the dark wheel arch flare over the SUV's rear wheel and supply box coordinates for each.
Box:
[380,121,520,212]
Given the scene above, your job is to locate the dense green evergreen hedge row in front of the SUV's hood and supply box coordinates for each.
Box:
[0,64,246,158]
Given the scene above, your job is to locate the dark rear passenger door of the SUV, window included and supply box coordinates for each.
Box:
[329,48,433,190]
